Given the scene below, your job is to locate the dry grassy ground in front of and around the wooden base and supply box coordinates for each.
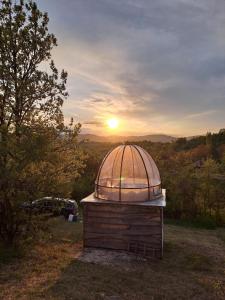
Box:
[0,218,225,300]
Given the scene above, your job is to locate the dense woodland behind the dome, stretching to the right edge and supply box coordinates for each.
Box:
[73,130,225,225]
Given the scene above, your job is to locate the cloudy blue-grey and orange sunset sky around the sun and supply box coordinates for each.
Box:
[37,0,225,136]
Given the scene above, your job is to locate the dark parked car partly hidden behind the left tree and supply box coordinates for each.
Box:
[22,197,78,219]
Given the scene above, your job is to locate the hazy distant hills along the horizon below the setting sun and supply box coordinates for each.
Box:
[78,134,176,143]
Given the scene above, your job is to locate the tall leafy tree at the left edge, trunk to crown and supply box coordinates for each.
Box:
[0,0,83,244]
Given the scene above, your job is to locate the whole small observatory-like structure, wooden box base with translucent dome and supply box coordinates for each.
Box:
[82,145,166,258]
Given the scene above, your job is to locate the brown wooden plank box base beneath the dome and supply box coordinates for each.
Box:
[83,203,163,257]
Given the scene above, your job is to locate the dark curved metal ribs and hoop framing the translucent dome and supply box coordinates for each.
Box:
[95,144,162,202]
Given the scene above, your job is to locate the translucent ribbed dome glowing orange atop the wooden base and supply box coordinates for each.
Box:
[95,145,162,202]
